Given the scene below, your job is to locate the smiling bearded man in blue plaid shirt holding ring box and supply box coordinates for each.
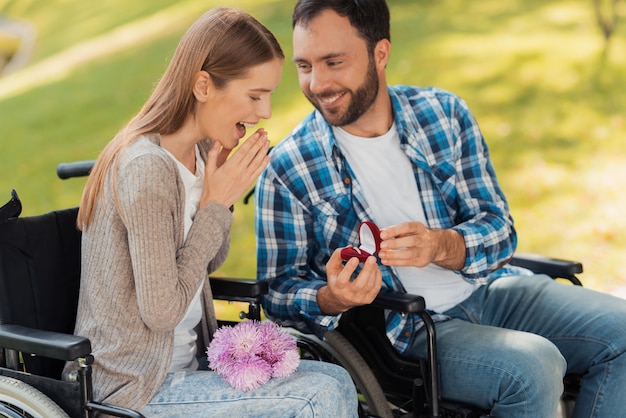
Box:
[255,0,626,418]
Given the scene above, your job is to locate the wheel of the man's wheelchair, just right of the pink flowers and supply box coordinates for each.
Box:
[291,330,393,418]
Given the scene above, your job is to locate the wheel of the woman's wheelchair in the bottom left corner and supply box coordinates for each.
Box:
[0,376,69,418]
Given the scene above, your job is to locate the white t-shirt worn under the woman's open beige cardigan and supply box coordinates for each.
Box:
[166,146,204,373]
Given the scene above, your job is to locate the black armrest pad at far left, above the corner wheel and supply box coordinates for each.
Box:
[0,324,91,361]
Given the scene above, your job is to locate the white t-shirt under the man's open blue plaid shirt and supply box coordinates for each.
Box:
[333,123,476,312]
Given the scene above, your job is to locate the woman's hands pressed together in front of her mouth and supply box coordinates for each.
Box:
[200,128,270,208]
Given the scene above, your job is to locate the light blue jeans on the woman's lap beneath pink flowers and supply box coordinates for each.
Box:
[141,360,358,418]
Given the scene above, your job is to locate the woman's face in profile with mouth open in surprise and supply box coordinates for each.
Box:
[197,58,283,149]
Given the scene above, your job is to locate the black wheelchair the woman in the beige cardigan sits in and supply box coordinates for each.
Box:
[0,191,267,418]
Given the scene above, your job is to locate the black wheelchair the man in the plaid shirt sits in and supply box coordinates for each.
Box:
[297,253,583,418]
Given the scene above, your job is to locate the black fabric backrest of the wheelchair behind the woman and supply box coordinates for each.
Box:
[0,208,81,377]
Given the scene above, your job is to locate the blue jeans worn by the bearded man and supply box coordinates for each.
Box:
[406,276,626,418]
